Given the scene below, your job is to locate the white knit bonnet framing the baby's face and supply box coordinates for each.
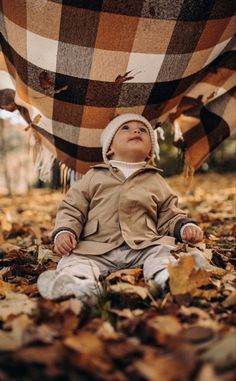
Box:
[101,113,159,163]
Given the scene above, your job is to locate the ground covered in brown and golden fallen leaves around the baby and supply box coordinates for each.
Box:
[0,174,236,381]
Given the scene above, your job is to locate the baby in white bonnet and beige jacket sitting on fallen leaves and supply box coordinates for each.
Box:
[38,113,204,299]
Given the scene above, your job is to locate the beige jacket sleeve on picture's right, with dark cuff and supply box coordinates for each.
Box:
[157,179,197,241]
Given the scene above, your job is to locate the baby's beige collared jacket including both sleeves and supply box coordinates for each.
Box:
[52,164,193,255]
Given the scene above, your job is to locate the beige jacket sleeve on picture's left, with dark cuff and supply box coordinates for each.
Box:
[52,172,92,240]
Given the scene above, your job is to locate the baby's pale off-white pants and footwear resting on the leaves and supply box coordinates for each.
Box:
[37,244,205,299]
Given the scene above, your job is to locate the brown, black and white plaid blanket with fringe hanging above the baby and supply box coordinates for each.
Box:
[0,0,236,180]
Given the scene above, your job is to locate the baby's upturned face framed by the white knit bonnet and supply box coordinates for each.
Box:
[107,121,152,162]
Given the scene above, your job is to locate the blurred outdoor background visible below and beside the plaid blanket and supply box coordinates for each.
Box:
[0,110,236,195]
